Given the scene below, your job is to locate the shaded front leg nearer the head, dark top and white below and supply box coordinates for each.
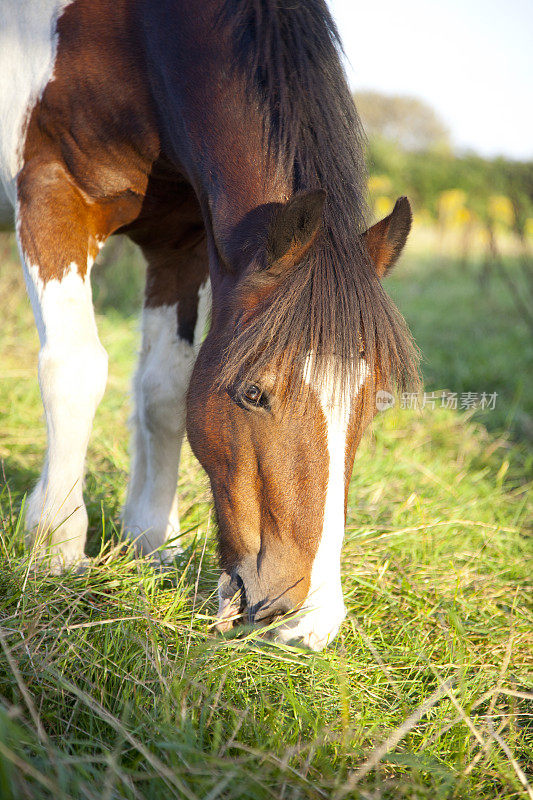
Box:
[123,234,210,566]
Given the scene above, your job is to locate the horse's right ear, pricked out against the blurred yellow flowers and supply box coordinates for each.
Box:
[361,197,413,278]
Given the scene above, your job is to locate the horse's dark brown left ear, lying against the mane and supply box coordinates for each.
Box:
[266,189,326,276]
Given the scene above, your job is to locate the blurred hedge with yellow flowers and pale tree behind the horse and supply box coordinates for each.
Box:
[354,92,533,241]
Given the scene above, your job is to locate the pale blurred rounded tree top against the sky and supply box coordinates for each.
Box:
[354,92,450,151]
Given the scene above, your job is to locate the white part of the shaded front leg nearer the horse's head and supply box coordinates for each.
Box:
[124,281,210,563]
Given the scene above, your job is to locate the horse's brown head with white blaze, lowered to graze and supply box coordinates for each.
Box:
[187,189,411,649]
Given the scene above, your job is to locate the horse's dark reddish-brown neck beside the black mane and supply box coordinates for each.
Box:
[140,0,292,272]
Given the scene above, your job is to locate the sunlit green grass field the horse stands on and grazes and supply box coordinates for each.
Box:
[0,228,533,800]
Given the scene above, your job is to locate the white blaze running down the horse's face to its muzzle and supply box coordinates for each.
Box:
[275,360,369,650]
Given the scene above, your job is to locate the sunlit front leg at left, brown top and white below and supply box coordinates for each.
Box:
[17,159,107,571]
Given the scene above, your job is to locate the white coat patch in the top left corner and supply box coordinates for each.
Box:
[0,0,72,205]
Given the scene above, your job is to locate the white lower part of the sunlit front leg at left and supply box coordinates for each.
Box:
[21,252,107,569]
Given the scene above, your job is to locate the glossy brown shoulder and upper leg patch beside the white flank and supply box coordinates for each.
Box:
[18,0,159,283]
